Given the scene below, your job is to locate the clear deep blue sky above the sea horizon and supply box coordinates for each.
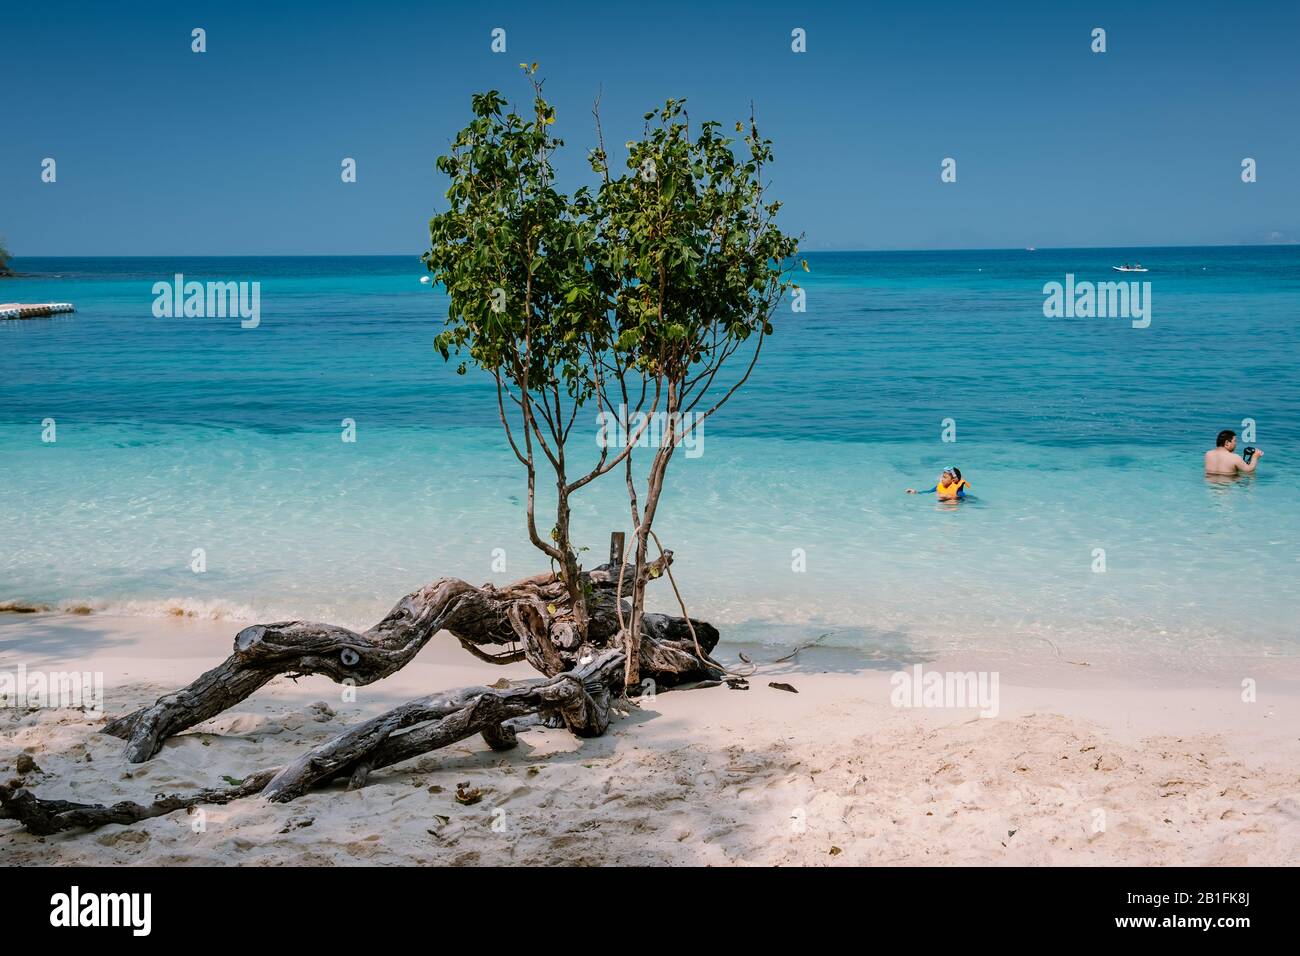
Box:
[0,0,1300,256]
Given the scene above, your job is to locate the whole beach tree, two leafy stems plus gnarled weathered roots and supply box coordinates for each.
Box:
[0,82,780,834]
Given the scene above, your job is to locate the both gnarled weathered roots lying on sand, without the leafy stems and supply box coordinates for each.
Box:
[0,551,725,834]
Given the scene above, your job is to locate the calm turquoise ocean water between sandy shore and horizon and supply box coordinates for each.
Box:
[0,247,1300,661]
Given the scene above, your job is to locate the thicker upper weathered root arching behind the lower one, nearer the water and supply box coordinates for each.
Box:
[103,553,722,763]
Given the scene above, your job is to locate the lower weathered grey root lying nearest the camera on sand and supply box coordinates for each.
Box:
[0,649,624,836]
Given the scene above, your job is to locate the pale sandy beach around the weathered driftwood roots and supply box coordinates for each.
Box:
[0,613,1300,865]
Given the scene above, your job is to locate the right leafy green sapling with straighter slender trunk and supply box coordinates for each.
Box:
[595,100,807,689]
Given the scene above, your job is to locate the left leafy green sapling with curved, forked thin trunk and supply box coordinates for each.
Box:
[424,70,654,639]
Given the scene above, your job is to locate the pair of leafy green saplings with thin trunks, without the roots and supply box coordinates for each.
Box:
[424,78,797,688]
